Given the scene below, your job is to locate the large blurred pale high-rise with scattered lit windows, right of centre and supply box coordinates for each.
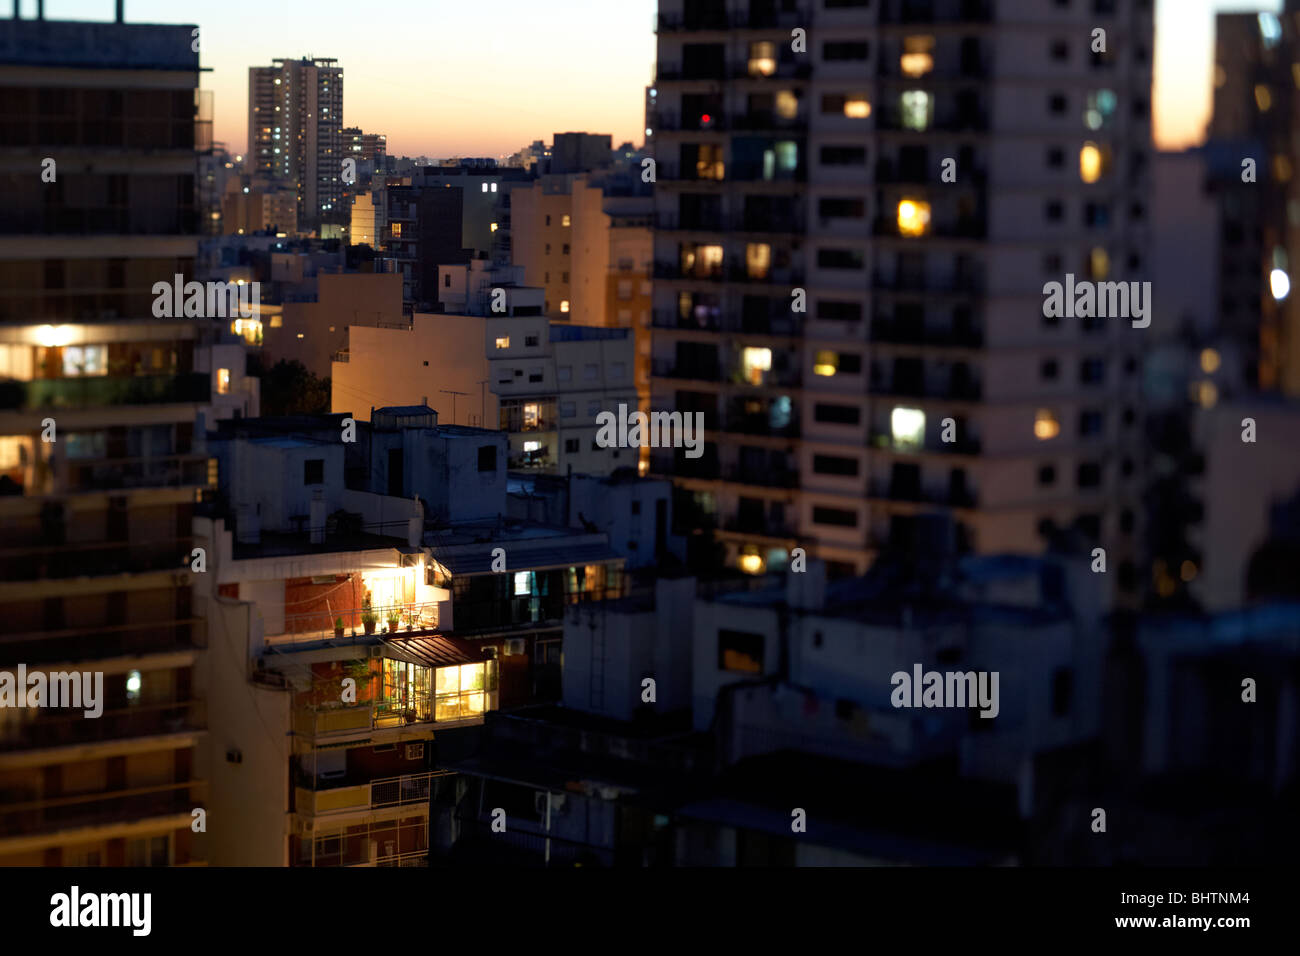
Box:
[647,0,1160,587]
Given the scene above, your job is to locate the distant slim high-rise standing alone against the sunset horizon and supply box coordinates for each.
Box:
[246,57,348,235]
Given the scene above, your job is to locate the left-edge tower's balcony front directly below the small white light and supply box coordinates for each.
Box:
[0,700,208,750]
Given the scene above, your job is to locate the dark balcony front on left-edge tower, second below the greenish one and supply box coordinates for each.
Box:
[0,537,194,581]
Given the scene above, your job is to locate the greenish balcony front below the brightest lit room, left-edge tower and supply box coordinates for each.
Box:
[0,372,212,411]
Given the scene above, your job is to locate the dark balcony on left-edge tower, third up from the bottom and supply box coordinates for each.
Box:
[0,618,208,666]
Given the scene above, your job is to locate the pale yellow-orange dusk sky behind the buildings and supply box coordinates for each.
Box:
[35,0,1281,157]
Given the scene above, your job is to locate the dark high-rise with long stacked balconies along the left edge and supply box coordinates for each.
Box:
[0,11,257,866]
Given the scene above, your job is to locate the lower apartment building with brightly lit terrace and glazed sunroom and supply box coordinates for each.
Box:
[195,406,623,866]
